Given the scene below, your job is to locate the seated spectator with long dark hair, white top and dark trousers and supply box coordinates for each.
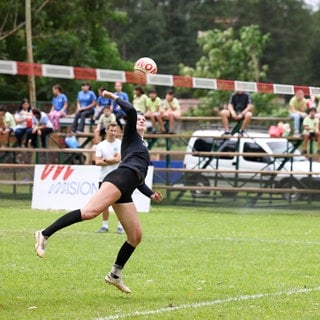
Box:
[14,98,32,147]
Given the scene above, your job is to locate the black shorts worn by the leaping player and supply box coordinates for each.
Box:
[103,167,141,203]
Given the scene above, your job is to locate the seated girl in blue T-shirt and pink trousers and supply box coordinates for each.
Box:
[49,84,68,131]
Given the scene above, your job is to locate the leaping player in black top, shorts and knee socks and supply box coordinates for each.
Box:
[35,91,163,293]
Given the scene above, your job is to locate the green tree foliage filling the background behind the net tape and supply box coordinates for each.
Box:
[0,0,320,102]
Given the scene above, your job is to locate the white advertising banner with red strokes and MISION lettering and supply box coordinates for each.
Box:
[32,164,153,212]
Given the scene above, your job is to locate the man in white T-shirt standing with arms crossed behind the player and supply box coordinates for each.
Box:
[95,121,124,234]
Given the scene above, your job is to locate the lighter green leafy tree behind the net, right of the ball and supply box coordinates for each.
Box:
[180,25,269,115]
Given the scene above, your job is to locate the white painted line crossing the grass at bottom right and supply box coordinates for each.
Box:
[94,286,320,320]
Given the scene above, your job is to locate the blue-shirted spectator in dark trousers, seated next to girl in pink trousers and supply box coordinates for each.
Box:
[71,82,97,133]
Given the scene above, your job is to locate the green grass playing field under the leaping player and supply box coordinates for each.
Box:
[0,199,320,320]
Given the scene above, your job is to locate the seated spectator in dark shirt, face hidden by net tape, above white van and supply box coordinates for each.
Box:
[220,91,253,135]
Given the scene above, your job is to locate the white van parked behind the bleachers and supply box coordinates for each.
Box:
[184,130,320,200]
